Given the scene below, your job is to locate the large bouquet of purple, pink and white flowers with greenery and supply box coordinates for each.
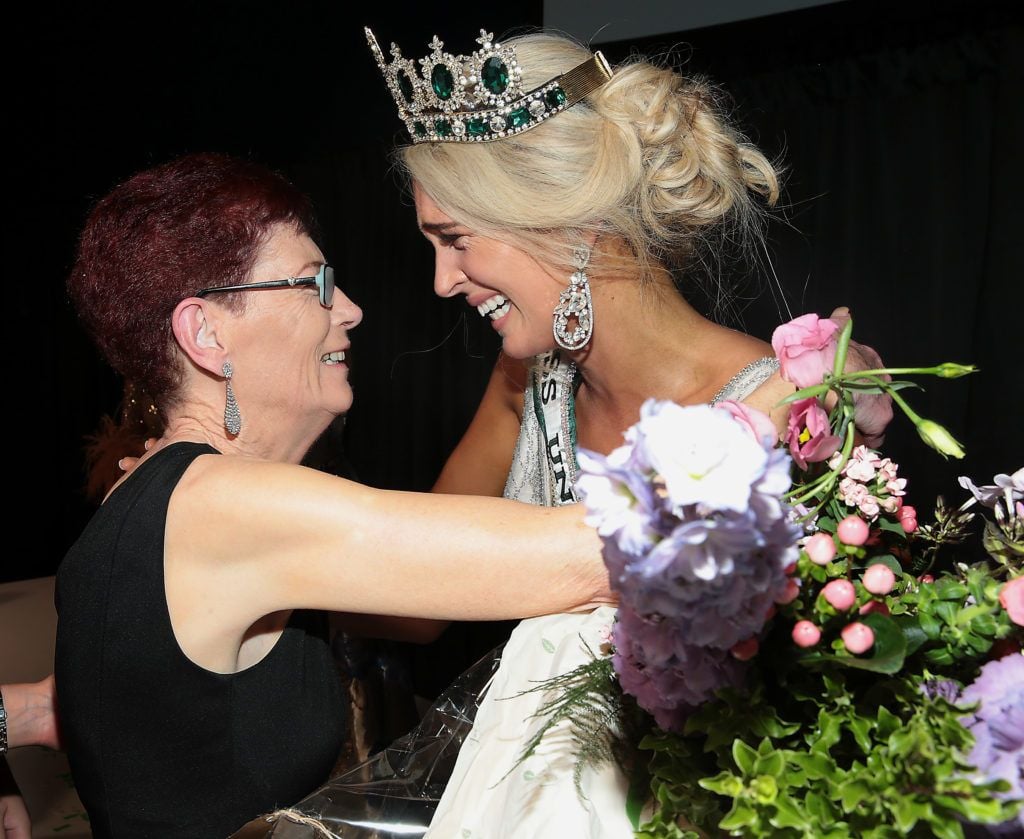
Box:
[530,316,1024,839]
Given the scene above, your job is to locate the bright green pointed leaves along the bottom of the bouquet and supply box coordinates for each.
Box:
[637,670,1016,839]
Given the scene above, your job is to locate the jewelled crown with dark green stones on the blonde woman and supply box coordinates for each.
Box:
[366,29,611,142]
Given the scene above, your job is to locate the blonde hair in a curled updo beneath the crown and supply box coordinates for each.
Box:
[399,34,779,301]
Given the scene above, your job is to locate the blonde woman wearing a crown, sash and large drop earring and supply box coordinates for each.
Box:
[368,31,889,837]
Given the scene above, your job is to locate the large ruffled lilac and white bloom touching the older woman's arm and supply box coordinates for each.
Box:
[577,400,802,728]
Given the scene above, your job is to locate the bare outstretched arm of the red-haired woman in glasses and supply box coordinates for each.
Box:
[172,456,609,635]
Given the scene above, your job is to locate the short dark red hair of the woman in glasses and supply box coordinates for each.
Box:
[68,154,313,408]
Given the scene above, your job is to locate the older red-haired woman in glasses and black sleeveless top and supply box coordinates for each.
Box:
[56,155,608,839]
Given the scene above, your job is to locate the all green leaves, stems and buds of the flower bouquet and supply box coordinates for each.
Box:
[523,344,1024,839]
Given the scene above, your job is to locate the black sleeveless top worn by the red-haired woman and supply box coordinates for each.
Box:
[54,443,344,839]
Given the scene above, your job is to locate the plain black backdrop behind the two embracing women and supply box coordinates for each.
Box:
[12,0,1024,602]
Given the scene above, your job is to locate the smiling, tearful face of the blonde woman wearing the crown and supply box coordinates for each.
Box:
[414,183,567,359]
